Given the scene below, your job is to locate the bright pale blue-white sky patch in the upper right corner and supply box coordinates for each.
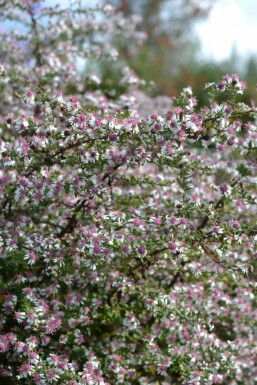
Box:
[195,0,257,61]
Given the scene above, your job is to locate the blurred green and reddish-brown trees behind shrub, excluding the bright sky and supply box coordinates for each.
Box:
[99,0,257,105]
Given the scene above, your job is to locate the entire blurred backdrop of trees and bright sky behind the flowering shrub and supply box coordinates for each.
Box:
[96,0,257,105]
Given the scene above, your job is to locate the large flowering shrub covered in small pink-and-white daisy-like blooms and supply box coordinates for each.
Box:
[0,0,257,385]
